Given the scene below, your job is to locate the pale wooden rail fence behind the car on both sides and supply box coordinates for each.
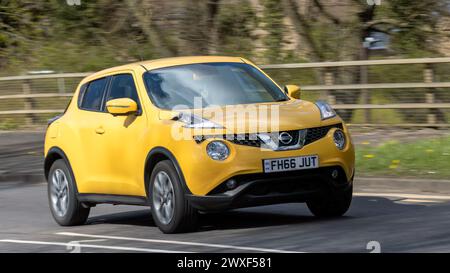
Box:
[0,58,450,127]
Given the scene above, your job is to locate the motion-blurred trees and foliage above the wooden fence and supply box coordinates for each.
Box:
[0,0,450,73]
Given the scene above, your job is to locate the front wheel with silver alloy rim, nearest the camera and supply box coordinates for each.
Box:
[148,160,198,233]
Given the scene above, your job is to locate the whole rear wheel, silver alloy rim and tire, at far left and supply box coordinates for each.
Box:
[47,159,90,226]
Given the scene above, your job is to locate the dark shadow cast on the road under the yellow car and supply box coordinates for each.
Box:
[87,196,427,232]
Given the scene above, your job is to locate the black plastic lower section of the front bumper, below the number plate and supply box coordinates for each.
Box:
[186,166,353,211]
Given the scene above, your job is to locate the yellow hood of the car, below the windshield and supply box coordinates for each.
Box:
[160,100,321,134]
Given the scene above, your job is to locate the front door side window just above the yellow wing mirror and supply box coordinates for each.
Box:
[106,74,139,105]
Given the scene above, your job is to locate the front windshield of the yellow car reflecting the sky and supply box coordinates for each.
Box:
[144,63,288,109]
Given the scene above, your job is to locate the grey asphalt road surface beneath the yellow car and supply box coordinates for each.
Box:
[0,182,450,252]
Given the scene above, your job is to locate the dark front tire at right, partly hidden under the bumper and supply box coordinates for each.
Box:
[306,184,353,218]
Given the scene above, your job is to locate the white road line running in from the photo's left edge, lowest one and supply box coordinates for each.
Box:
[0,239,190,253]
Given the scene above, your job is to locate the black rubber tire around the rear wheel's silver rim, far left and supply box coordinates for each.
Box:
[47,159,90,226]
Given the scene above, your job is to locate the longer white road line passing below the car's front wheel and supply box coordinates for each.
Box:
[56,232,304,253]
